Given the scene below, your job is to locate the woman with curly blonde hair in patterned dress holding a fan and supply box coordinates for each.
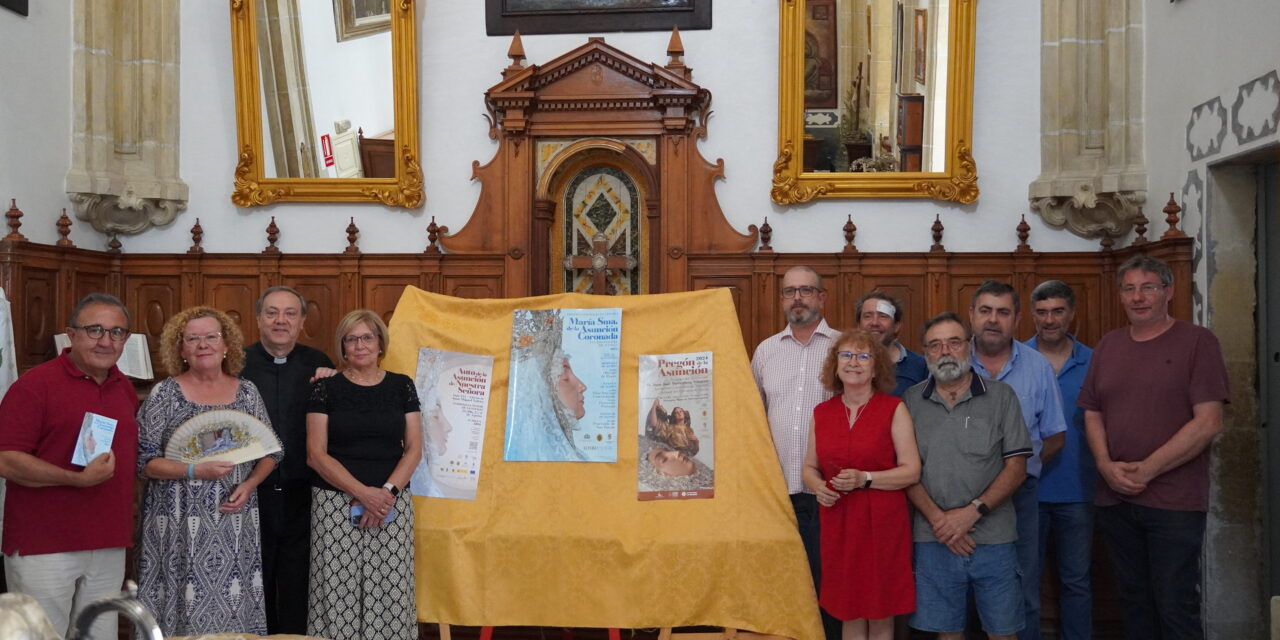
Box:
[138,307,283,636]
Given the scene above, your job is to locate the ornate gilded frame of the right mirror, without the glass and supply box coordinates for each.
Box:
[769,0,978,205]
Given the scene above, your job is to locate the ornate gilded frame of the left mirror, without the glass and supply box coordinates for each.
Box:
[230,0,424,209]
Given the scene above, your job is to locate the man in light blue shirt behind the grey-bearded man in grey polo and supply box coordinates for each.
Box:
[969,280,1066,640]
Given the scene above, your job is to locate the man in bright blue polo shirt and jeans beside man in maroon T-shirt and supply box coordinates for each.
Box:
[1027,280,1098,640]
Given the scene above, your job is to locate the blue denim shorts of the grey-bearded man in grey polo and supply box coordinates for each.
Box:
[911,543,1024,635]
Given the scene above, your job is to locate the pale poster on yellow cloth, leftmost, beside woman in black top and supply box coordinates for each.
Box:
[410,347,493,500]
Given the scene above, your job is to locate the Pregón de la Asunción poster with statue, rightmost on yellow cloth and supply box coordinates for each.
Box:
[636,351,716,500]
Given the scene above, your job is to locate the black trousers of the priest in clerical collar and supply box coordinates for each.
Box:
[257,480,311,635]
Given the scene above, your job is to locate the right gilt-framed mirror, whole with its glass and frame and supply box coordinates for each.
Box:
[771,0,978,205]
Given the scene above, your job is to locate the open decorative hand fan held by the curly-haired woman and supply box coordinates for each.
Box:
[164,408,280,465]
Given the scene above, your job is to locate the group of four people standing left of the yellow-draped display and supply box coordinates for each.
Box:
[0,287,421,639]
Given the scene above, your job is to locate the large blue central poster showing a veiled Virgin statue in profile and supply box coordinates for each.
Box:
[503,308,622,462]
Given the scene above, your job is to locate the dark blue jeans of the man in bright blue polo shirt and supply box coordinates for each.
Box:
[1039,502,1093,640]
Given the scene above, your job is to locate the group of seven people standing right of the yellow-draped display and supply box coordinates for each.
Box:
[751,256,1229,640]
